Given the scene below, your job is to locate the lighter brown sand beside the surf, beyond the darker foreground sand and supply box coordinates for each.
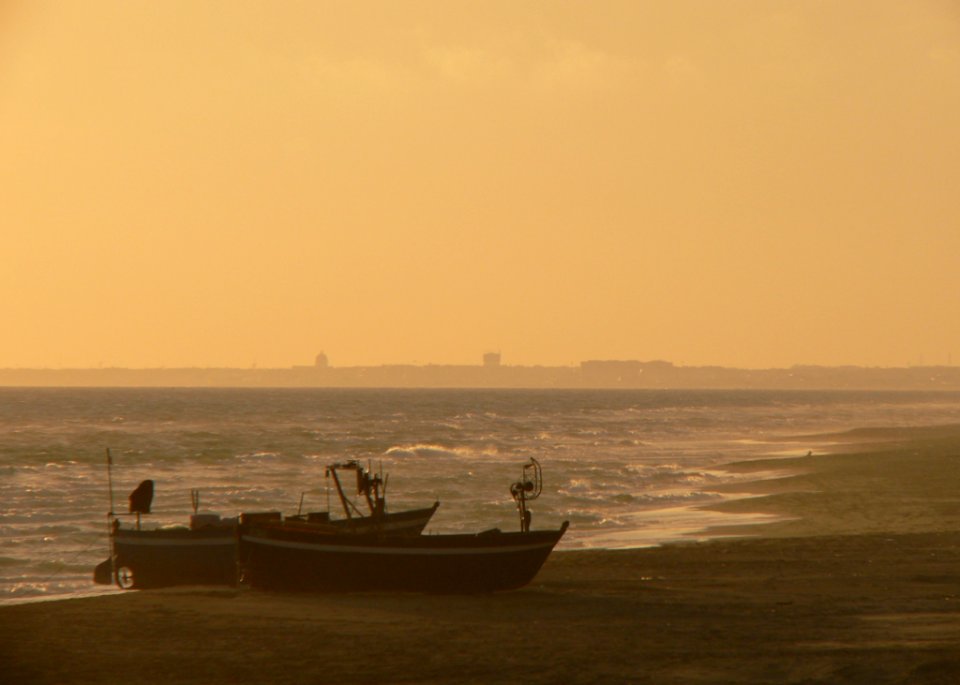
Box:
[700,425,960,537]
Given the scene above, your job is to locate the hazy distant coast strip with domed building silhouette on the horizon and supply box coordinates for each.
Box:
[0,355,960,392]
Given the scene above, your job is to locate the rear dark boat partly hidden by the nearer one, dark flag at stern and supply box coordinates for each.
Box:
[94,454,439,589]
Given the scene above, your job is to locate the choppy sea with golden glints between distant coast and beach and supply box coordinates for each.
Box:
[0,388,960,604]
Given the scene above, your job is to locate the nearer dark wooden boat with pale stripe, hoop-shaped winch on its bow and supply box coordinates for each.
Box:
[239,460,568,593]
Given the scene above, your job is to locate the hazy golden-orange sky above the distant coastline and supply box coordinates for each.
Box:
[0,0,960,367]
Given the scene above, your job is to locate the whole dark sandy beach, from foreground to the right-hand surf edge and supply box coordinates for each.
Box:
[0,427,960,684]
